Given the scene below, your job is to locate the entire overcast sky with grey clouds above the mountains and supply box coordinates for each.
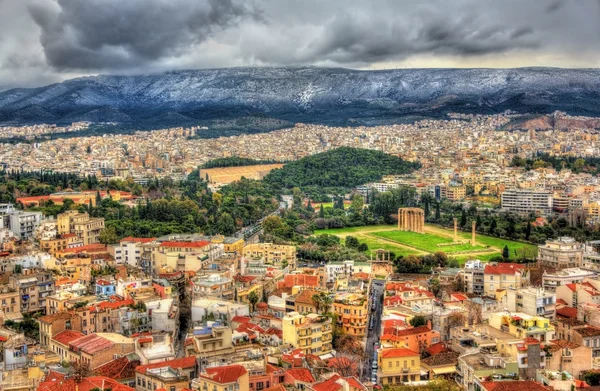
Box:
[0,0,600,90]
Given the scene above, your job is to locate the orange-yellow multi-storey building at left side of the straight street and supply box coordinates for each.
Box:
[333,293,369,337]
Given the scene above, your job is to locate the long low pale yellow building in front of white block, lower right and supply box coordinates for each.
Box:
[489,312,555,343]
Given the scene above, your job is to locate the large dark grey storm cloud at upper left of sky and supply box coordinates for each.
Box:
[29,0,257,70]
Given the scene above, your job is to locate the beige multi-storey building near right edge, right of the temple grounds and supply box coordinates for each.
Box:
[538,236,584,269]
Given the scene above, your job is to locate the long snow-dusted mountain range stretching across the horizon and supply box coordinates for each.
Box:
[0,67,600,131]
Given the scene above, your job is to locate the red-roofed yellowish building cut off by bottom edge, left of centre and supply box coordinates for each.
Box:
[192,364,250,391]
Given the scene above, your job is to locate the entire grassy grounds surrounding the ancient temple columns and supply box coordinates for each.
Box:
[315,224,537,263]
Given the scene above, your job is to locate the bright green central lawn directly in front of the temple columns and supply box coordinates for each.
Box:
[372,231,485,254]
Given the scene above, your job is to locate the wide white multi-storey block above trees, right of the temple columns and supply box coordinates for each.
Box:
[501,189,552,216]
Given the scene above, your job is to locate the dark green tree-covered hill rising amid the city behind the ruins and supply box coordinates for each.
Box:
[264,147,419,188]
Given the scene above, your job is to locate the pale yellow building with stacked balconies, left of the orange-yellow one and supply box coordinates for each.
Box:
[281,312,332,356]
